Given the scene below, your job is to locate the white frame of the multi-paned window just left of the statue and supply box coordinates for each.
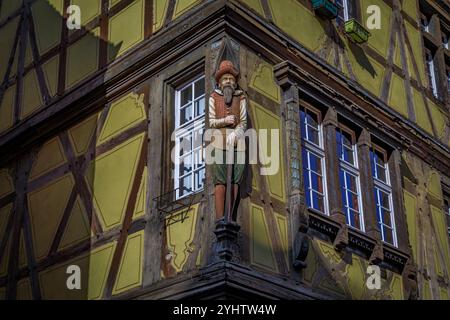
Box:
[172,73,207,200]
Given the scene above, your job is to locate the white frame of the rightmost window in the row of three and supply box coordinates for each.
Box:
[372,149,398,247]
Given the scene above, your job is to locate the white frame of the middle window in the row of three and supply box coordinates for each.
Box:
[338,127,366,232]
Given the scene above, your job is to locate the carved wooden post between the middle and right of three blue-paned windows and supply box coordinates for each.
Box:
[357,129,383,264]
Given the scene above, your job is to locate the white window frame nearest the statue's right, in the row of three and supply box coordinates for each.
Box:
[299,104,330,216]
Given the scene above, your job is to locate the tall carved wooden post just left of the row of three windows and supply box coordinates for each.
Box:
[274,61,309,269]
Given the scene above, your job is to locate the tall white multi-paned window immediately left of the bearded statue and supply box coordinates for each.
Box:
[174,77,205,199]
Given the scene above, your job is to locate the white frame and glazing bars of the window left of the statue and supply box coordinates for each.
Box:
[174,75,207,200]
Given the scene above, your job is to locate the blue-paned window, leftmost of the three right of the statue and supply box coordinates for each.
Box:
[300,109,328,214]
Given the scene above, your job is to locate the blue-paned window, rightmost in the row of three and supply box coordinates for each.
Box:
[370,146,397,246]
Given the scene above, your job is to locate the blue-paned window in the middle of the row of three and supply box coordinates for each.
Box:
[336,128,364,231]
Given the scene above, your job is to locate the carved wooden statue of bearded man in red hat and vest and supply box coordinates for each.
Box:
[209,60,247,220]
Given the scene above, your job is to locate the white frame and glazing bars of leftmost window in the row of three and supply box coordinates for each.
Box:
[300,107,330,215]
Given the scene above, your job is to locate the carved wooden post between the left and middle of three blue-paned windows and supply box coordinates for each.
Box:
[323,108,348,251]
